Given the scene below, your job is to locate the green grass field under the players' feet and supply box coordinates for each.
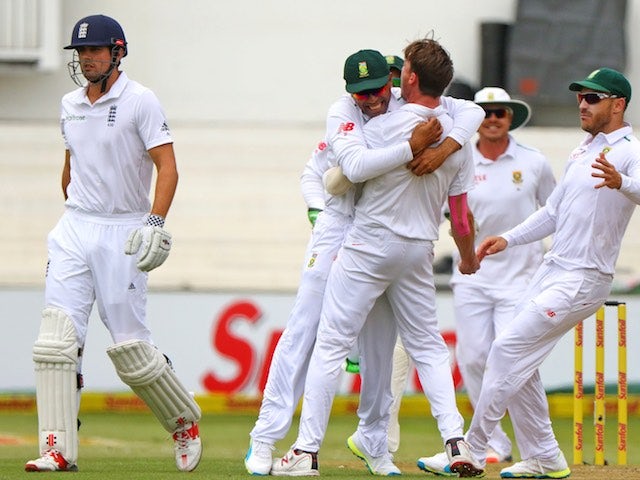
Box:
[0,413,640,480]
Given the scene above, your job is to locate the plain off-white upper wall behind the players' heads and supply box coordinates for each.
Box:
[0,0,640,124]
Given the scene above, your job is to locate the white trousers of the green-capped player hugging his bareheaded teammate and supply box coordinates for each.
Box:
[250,212,395,454]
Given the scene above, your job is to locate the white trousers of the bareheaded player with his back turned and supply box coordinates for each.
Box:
[295,226,464,453]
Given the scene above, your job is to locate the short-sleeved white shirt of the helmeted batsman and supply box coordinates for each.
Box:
[60,72,173,215]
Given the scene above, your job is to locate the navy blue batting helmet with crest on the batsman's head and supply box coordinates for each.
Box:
[64,15,127,56]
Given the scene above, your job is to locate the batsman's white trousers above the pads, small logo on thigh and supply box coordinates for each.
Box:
[45,209,153,347]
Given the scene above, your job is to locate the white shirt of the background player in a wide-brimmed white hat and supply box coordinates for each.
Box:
[451,136,556,288]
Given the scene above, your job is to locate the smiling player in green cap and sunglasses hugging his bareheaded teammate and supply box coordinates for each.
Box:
[245,50,480,475]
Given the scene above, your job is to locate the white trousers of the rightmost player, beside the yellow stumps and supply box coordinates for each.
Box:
[467,263,613,460]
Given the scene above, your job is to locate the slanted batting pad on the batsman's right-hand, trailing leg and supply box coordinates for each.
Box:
[107,340,201,433]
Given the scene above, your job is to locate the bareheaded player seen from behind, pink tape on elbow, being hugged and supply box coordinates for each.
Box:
[271,39,480,476]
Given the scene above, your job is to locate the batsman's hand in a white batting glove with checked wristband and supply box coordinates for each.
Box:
[124,225,171,272]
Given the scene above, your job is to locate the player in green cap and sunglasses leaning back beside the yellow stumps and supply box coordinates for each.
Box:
[467,68,640,478]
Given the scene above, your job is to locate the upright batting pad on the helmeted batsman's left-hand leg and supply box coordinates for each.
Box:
[33,307,79,463]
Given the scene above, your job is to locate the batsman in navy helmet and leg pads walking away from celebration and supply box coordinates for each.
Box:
[25,15,202,472]
